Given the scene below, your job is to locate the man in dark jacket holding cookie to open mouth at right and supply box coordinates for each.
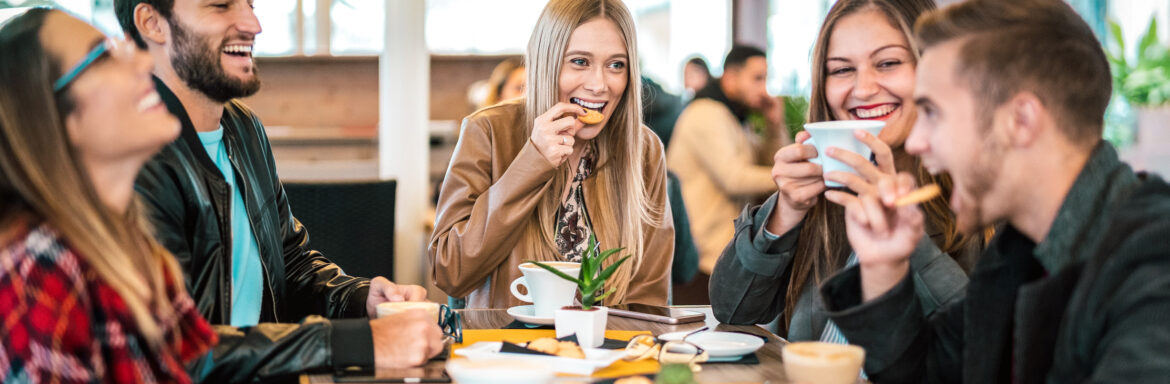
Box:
[821,0,1170,383]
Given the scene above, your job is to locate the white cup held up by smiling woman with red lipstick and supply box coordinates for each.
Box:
[805,121,886,187]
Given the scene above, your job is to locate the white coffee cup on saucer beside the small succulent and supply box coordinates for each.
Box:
[511,261,581,318]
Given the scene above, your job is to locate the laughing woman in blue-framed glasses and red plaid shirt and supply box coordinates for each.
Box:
[0,8,215,383]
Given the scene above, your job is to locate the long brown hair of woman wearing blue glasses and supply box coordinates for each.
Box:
[0,8,184,349]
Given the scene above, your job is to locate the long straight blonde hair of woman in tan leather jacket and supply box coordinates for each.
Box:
[525,0,665,303]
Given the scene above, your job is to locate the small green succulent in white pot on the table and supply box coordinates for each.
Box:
[530,234,629,348]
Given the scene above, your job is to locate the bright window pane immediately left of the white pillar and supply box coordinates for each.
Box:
[329,0,386,55]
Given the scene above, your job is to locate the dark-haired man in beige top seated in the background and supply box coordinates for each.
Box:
[667,46,786,293]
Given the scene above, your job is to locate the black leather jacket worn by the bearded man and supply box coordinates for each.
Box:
[136,77,373,383]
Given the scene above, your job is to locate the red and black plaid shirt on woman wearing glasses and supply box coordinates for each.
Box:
[0,224,216,383]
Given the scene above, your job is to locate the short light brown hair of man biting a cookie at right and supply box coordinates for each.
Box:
[915,0,1113,144]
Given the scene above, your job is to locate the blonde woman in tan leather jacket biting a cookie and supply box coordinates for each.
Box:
[428,0,674,308]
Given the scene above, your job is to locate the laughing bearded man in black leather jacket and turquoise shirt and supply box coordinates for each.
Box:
[115,0,442,383]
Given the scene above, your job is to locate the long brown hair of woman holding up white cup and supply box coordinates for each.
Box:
[784,0,971,327]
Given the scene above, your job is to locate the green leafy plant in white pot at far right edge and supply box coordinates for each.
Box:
[1106,16,1170,172]
